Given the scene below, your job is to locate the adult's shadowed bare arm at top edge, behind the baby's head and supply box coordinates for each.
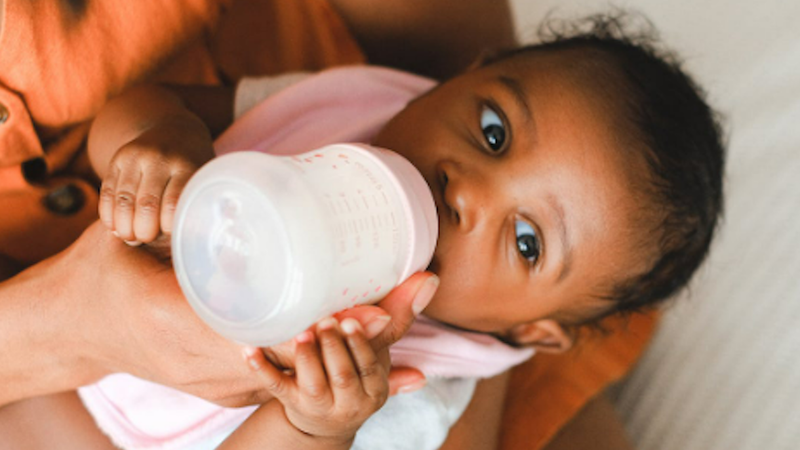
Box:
[330,0,516,79]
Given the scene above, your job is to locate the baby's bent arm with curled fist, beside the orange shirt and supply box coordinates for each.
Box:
[88,86,214,243]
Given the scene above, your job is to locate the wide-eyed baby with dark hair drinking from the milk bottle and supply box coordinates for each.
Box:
[90,14,724,448]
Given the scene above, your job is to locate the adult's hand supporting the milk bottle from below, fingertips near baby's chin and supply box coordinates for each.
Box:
[42,222,438,406]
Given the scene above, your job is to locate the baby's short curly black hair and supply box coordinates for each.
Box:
[484,11,725,326]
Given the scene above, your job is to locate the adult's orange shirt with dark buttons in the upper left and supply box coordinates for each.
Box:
[0,0,364,267]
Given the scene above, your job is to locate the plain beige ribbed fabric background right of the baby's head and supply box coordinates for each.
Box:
[512,0,800,450]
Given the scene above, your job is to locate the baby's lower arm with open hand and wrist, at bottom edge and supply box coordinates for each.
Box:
[219,319,389,450]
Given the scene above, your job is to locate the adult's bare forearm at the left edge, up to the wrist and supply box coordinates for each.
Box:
[0,256,102,405]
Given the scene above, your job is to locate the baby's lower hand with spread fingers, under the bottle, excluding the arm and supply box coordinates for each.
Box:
[245,318,389,442]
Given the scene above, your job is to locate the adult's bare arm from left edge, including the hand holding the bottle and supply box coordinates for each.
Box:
[0,222,433,406]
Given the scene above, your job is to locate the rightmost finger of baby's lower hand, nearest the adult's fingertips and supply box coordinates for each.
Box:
[341,319,389,405]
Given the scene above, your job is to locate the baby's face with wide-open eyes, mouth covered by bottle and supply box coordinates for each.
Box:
[375,51,645,332]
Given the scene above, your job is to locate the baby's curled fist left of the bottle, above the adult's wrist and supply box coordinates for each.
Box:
[99,127,203,245]
